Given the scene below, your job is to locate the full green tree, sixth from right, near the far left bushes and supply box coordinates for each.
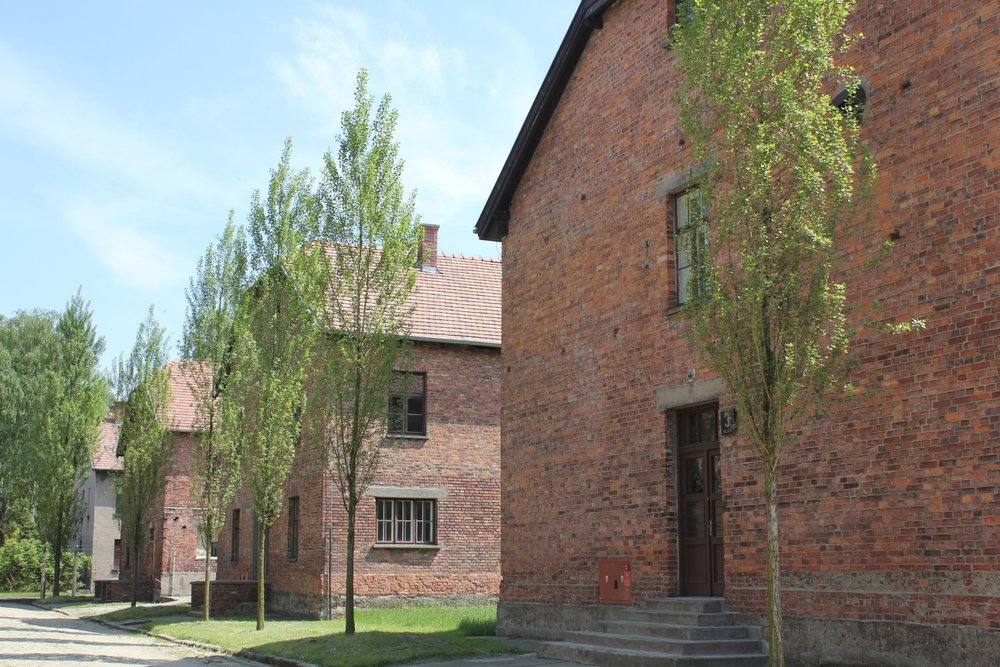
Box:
[32,292,109,595]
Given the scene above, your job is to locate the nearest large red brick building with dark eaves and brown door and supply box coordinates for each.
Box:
[476,0,1000,665]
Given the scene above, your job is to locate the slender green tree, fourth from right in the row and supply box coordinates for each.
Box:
[181,213,246,621]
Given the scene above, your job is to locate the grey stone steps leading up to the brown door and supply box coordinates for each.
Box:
[537,598,767,667]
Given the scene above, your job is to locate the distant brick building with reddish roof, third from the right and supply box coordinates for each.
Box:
[95,361,216,599]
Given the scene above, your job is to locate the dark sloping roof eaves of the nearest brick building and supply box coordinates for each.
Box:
[475,0,616,241]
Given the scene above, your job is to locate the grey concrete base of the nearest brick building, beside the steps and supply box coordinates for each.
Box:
[497,602,1000,667]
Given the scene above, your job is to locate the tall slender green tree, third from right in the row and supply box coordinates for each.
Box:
[219,141,323,630]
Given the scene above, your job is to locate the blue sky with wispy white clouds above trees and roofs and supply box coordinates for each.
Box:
[0,0,578,367]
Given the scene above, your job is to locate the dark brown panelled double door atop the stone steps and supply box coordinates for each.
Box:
[677,404,725,596]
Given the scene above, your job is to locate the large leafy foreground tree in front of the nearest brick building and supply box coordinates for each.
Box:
[672,0,874,665]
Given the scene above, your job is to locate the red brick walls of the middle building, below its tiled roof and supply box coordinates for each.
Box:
[219,343,500,602]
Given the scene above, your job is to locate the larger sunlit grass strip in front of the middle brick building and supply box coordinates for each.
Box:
[143,605,521,667]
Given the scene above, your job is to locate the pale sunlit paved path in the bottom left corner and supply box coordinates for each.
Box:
[0,602,247,667]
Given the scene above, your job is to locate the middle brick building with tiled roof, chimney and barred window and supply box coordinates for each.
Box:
[215,225,501,616]
